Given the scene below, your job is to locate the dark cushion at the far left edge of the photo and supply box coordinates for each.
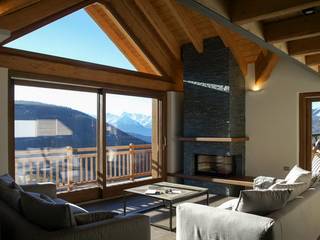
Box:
[0,174,23,212]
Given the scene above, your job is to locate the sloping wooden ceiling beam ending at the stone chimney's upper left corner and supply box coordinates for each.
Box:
[135,0,181,59]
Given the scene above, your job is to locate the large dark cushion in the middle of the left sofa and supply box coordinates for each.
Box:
[21,192,75,231]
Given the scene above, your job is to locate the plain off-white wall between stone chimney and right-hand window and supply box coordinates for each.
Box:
[246,59,320,177]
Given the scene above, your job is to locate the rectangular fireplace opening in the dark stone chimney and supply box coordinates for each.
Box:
[195,154,235,177]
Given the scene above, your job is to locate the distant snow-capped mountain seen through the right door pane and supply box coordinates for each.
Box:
[107,112,152,142]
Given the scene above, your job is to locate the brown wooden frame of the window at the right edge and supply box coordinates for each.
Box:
[299,92,320,170]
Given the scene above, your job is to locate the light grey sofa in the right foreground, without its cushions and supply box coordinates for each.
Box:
[177,185,320,240]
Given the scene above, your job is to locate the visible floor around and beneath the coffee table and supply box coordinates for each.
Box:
[81,195,229,240]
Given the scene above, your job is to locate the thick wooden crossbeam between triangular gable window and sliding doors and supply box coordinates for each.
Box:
[0,47,175,91]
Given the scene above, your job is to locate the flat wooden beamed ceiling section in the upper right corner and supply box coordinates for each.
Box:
[195,0,320,72]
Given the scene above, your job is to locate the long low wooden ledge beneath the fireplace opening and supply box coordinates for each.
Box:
[167,173,254,188]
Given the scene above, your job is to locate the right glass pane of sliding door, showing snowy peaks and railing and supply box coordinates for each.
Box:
[106,94,158,185]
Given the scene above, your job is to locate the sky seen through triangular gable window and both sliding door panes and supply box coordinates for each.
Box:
[6,10,152,115]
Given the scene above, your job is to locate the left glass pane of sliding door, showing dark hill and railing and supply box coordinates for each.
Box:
[15,85,98,191]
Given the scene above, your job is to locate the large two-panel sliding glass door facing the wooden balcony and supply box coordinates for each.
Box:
[14,80,162,191]
